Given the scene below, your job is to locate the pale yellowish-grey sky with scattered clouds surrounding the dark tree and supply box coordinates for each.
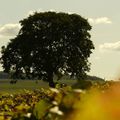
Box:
[0,0,120,80]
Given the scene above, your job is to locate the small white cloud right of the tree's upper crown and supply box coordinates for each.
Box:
[88,17,112,24]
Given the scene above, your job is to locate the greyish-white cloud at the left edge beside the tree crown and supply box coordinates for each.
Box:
[0,24,20,36]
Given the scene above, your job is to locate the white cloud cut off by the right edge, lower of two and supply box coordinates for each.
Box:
[99,41,120,52]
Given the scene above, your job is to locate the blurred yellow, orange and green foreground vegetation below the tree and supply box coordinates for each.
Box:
[0,79,120,120]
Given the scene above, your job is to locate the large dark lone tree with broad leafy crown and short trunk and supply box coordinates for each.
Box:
[1,12,94,87]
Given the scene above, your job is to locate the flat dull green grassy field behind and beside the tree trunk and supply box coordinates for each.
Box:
[0,80,76,93]
